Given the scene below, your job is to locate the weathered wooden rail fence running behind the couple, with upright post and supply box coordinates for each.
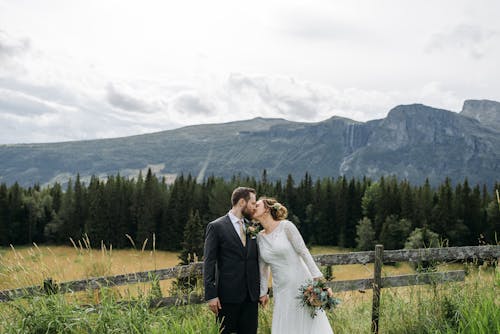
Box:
[0,245,500,333]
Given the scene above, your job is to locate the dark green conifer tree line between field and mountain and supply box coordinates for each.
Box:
[0,170,500,263]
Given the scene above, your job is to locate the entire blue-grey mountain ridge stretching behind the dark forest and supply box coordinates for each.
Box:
[0,101,500,186]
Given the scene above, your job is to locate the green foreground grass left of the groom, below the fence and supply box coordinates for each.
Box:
[0,289,219,334]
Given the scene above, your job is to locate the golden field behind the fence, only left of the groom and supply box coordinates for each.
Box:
[0,241,179,293]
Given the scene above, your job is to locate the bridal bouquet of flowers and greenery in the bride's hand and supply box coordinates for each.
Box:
[297,281,340,318]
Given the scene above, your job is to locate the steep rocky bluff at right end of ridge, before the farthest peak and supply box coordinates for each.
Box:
[340,104,500,184]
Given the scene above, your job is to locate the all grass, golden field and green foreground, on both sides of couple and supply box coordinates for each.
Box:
[0,246,500,334]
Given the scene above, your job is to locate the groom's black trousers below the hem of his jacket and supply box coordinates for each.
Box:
[217,297,259,334]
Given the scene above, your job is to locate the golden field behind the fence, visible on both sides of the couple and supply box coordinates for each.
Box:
[0,246,460,290]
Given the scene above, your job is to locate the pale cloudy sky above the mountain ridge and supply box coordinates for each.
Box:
[0,0,500,144]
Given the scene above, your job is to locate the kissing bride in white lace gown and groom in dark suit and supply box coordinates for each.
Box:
[203,187,333,334]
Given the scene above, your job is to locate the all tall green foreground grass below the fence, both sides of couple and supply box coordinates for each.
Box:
[0,268,500,334]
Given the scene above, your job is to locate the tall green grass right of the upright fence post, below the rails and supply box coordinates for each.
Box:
[381,267,500,333]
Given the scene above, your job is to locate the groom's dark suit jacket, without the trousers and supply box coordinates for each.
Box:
[203,215,260,303]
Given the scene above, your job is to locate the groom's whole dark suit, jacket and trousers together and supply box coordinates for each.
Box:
[203,215,260,333]
